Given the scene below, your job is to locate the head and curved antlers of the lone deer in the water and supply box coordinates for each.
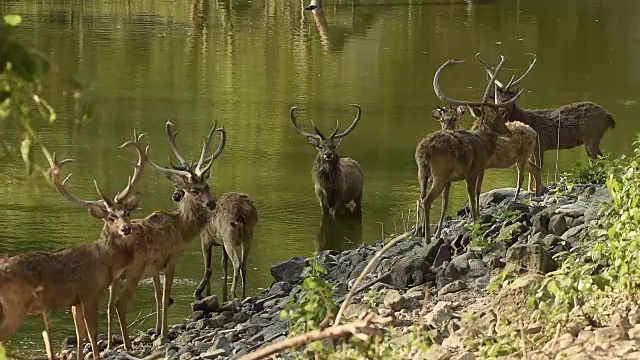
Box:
[289,104,362,162]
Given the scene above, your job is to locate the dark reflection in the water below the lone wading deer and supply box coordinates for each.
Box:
[315,209,362,251]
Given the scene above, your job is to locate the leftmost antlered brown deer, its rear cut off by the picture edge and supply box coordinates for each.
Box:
[0,140,144,359]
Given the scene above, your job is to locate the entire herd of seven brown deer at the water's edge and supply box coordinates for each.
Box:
[0,54,615,359]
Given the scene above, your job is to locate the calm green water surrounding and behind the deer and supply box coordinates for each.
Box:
[0,0,640,354]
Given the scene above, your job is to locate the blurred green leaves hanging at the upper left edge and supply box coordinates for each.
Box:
[0,15,91,177]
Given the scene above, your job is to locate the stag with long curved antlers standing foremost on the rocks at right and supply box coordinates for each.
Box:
[415,57,520,241]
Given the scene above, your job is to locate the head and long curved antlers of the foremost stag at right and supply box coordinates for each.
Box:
[433,56,523,134]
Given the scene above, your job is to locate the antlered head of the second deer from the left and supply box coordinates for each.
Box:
[147,121,227,210]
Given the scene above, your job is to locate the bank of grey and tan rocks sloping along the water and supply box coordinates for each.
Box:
[69,184,624,360]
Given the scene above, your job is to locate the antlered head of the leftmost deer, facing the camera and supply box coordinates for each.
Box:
[43,132,146,236]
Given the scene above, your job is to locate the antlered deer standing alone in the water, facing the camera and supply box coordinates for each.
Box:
[290,104,364,215]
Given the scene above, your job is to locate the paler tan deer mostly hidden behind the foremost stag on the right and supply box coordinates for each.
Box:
[431,107,542,201]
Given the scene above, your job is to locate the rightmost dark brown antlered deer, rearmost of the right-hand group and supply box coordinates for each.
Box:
[476,54,616,188]
